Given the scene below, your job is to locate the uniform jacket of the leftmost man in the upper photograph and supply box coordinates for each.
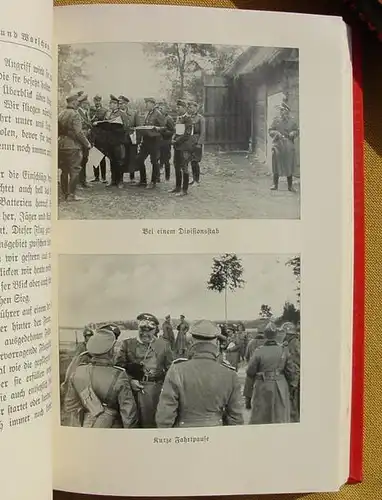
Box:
[58,106,90,150]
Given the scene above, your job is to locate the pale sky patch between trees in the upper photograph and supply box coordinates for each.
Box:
[67,43,172,102]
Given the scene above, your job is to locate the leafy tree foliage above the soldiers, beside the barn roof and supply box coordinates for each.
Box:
[143,43,242,102]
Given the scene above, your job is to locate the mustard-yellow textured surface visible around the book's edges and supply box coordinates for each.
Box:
[54,0,382,500]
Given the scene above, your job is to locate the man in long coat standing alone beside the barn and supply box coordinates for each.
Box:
[269,99,298,192]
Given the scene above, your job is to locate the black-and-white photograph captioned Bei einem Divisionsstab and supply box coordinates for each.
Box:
[58,42,300,220]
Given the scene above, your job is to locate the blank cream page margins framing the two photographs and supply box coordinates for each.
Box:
[54,6,352,496]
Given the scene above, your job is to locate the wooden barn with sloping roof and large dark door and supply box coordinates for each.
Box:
[204,47,299,175]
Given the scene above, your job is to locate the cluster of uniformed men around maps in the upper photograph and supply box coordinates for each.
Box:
[58,91,205,201]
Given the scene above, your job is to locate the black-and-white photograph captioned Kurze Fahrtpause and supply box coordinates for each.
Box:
[59,253,301,429]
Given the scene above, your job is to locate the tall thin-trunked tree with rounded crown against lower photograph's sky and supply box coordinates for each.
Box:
[207,253,245,323]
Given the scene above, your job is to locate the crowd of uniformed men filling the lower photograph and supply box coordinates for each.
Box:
[61,313,300,428]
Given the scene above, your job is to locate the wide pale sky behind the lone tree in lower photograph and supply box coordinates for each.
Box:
[59,254,296,328]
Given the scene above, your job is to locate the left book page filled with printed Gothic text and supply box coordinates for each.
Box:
[0,0,53,500]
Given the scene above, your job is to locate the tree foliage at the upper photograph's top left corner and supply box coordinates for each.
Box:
[57,45,93,106]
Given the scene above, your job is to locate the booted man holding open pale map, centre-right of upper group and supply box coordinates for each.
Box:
[137,97,165,188]
